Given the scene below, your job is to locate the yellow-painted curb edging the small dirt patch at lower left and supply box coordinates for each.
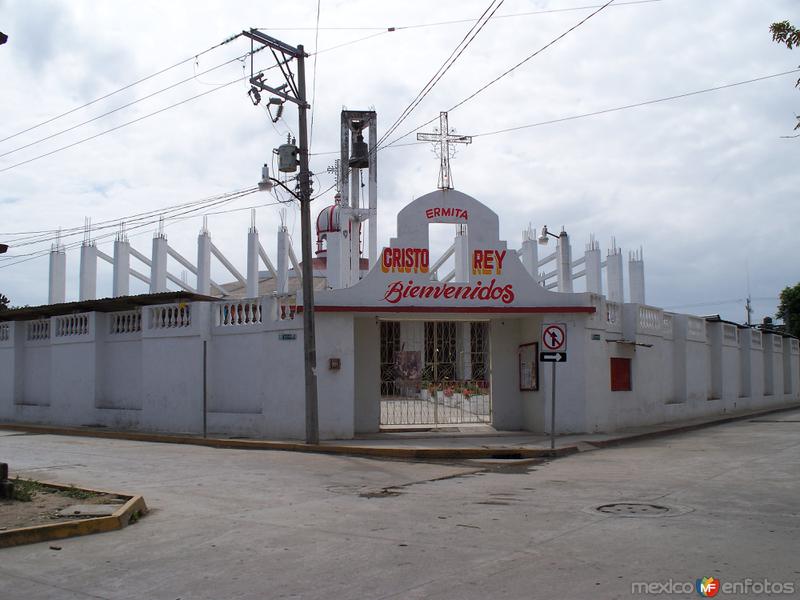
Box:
[0,481,147,548]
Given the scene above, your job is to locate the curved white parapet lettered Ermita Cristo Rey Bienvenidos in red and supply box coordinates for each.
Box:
[315,190,588,312]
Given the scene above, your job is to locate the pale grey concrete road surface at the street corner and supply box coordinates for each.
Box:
[0,411,800,600]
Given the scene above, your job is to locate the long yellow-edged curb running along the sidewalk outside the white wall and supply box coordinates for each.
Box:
[0,403,800,460]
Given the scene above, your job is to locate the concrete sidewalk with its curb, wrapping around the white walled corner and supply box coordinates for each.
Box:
[0,403,800,459]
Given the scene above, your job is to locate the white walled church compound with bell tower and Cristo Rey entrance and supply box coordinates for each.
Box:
[0,113,800,439]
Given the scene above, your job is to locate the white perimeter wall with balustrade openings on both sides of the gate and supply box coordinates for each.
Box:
[0,294,800,439]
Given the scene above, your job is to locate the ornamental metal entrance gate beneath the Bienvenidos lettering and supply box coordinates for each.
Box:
[380,321,491,425]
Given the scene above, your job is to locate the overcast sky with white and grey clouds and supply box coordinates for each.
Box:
[0,0,800,321]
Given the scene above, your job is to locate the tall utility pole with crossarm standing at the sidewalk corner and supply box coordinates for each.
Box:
[242,29,319,444]
